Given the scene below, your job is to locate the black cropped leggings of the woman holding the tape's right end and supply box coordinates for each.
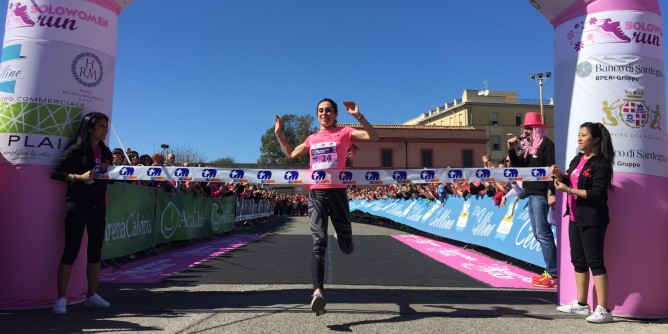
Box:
[568,222,608,276]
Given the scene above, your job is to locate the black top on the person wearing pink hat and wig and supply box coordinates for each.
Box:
[508,138,554,196]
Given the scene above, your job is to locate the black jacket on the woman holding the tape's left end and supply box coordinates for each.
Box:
[51,144,112,205]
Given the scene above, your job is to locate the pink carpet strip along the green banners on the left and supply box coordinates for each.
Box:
[100,234,264,283]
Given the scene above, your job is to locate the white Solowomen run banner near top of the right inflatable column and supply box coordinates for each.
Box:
[554,10,664,64]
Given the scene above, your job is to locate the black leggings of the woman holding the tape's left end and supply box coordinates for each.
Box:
[60,202,107,265]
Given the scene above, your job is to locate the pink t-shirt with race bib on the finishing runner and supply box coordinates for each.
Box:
[304,127,355,189]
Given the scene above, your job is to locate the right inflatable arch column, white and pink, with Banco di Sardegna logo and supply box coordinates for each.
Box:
[529,0,668,318]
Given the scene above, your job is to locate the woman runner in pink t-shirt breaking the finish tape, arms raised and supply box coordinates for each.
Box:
[274,99,378,315]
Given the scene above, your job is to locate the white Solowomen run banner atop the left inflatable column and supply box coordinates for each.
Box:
[4,0,118,57]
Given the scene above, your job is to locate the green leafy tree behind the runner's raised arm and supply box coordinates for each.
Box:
[257,114,318,164]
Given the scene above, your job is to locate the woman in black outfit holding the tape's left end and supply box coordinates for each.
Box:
[51,112,112,314]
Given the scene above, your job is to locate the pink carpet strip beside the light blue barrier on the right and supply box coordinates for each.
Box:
[392,235,555,290]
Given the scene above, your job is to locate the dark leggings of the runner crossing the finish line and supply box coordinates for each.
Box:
[308,188,353,289]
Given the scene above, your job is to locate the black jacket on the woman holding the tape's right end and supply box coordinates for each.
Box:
[562,153,612,226]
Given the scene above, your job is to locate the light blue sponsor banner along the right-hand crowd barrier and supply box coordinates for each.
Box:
[350,197,556,267]
